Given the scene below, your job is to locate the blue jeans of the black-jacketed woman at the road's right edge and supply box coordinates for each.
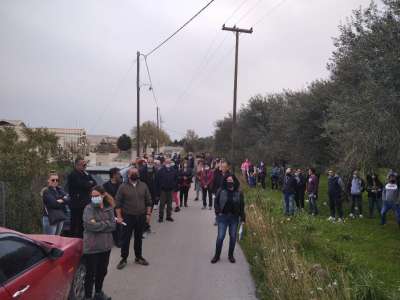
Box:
[215,214,239,258]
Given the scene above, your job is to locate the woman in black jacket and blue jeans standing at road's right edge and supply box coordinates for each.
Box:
[211,175,246,264]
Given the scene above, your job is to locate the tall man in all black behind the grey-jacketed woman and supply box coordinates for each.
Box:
[67,158,96,238]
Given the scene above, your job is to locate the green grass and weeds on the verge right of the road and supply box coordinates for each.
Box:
[242,179,400,300]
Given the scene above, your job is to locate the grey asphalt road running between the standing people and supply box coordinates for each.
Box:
[104,191,256,300]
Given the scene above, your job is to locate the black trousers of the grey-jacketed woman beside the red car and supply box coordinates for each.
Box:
[84,251,111,298]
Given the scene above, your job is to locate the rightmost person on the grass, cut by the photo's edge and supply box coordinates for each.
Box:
[381,172,400,228]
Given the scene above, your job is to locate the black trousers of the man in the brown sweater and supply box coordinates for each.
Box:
[121,215,146,259]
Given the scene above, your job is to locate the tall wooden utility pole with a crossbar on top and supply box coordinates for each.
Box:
[222,24,253,172]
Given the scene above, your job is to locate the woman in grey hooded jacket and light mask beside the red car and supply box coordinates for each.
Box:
[83,186,116,300]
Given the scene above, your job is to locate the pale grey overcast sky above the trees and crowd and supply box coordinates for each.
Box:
[0,0,370,138]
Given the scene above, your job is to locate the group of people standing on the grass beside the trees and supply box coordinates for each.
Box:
[241,159,400,227]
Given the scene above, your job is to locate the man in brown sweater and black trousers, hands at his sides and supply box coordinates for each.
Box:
[116,168,153,270]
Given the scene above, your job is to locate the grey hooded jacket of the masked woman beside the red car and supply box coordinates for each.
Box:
[83,204,116,254]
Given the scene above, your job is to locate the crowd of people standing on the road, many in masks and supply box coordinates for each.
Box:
[42,153,245,300]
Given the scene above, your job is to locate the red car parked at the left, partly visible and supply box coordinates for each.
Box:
[0,227,85,300]
